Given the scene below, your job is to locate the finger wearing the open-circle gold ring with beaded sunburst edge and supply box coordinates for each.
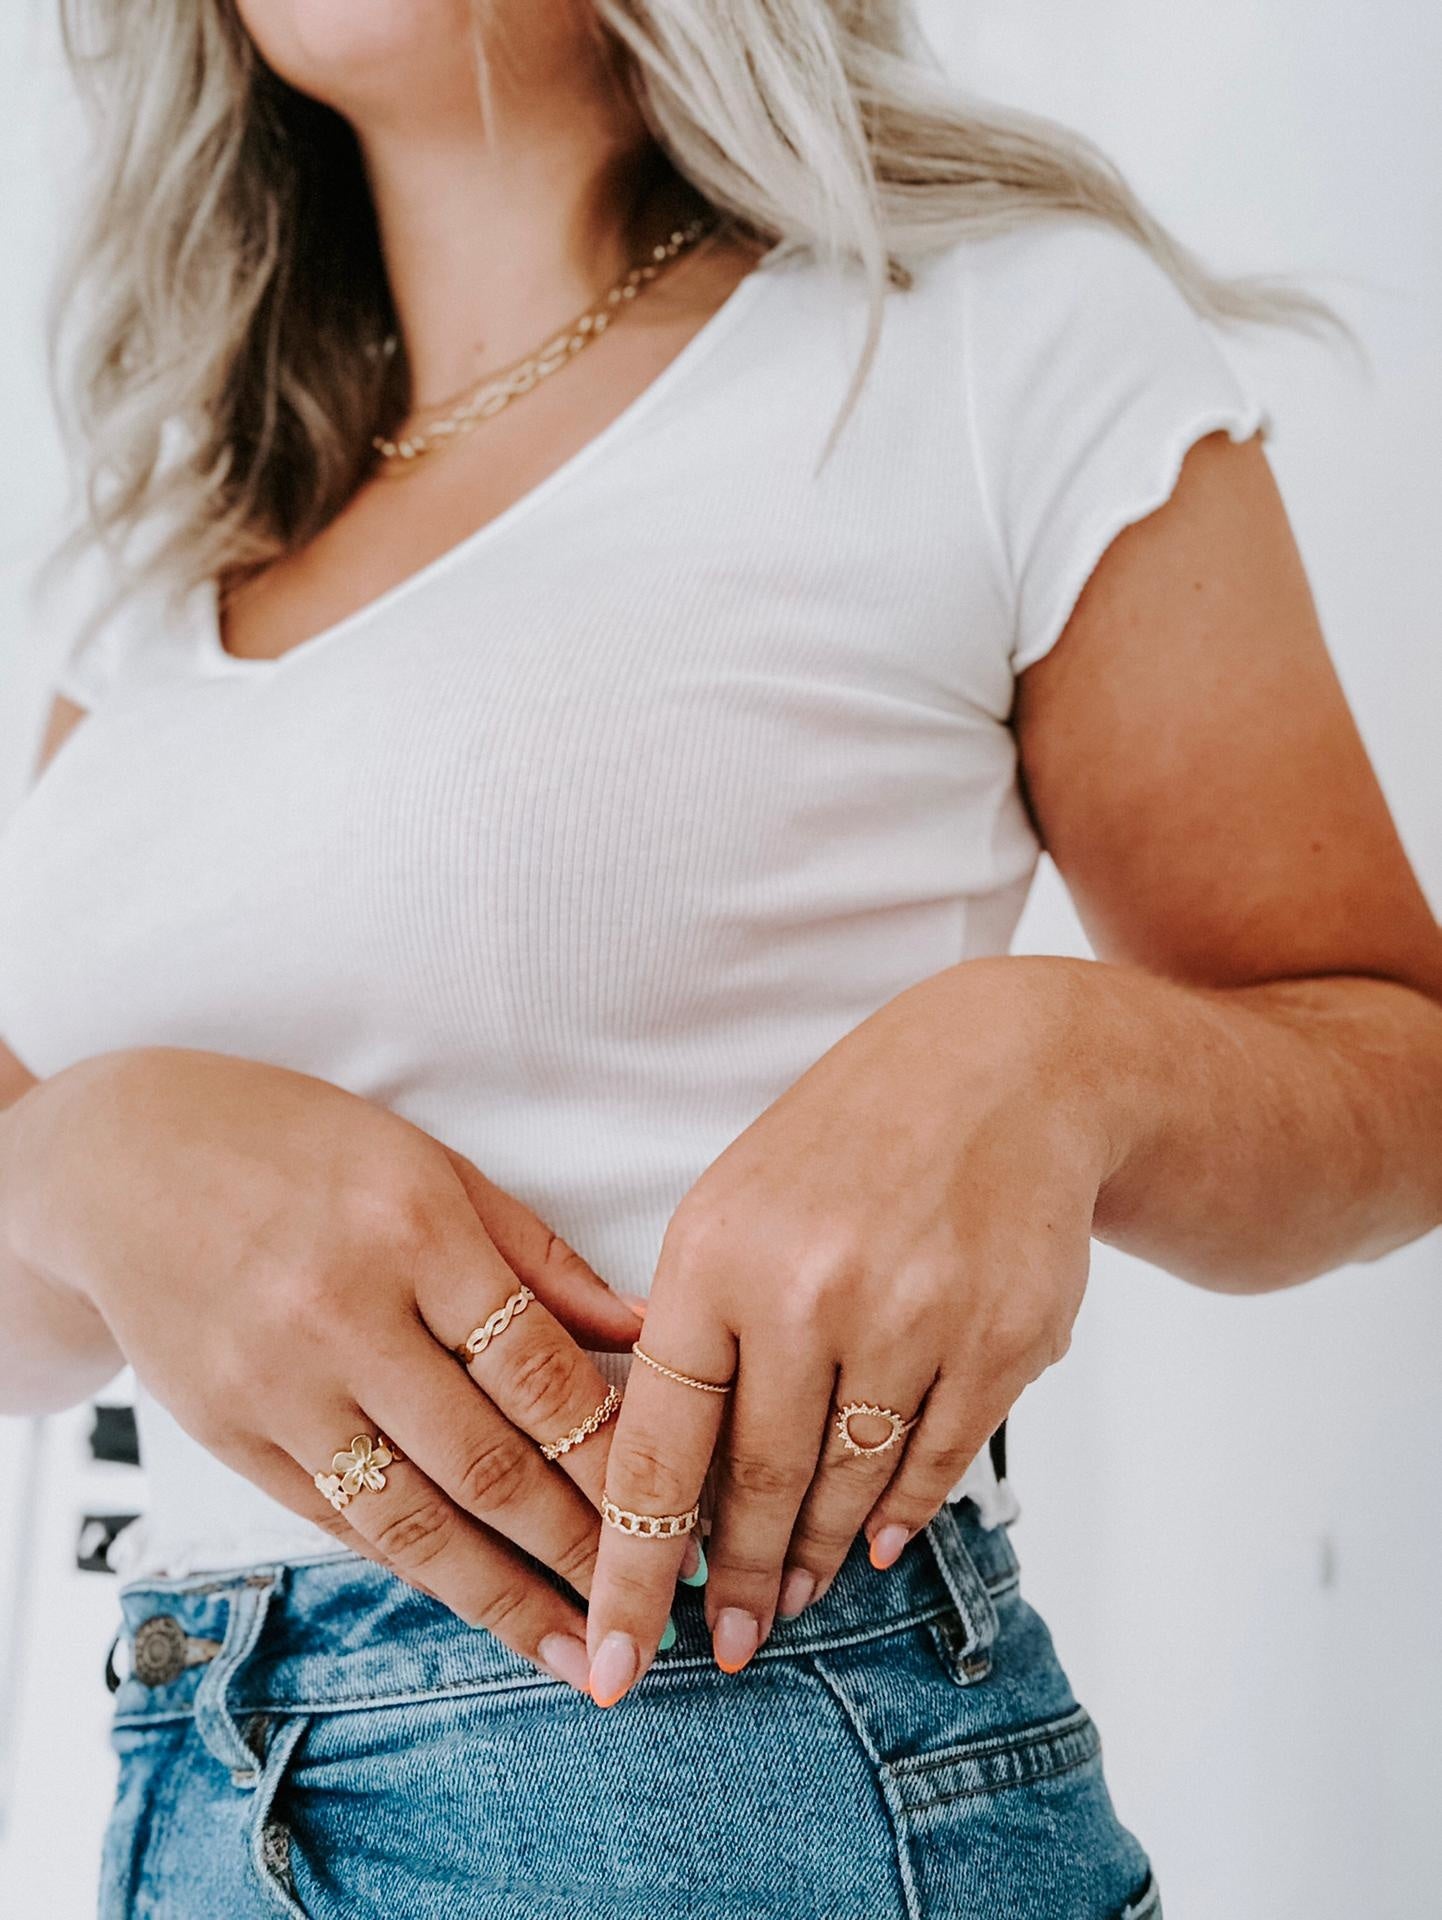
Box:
[781,1354,937,1615]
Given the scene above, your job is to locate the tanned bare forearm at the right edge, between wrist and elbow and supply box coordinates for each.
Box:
[1012,960,1442,1292]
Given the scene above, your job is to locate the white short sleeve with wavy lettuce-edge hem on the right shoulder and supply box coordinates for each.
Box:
[962,215,1271,674]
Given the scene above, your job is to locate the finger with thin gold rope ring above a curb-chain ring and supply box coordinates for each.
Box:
[586,1302,735,1707]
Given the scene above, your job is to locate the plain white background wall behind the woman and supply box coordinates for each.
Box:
[0,0,1442,1920]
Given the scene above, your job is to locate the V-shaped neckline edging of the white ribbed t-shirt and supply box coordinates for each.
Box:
[196,240,787,676]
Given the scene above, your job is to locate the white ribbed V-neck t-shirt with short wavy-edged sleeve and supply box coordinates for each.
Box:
[0,215,1267,1578]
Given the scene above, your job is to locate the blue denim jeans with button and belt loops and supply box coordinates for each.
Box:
[100,1500,1162,1920]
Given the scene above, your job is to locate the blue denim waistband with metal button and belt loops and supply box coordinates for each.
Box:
[115,1500,1018,1768]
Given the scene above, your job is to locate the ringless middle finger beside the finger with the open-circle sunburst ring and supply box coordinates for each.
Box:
[707,1338,833,1672]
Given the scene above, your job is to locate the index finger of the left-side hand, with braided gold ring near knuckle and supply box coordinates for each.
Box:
[417,1263,620,1520]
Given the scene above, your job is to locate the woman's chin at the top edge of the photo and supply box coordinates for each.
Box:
[236,0,476,117]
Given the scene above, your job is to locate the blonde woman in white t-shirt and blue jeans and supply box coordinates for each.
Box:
[0,0,1442,1920]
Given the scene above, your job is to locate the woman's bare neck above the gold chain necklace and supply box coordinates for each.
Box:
[357,60,701,411]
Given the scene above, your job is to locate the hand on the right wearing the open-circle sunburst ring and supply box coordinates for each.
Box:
[588,958,1114,1705]
